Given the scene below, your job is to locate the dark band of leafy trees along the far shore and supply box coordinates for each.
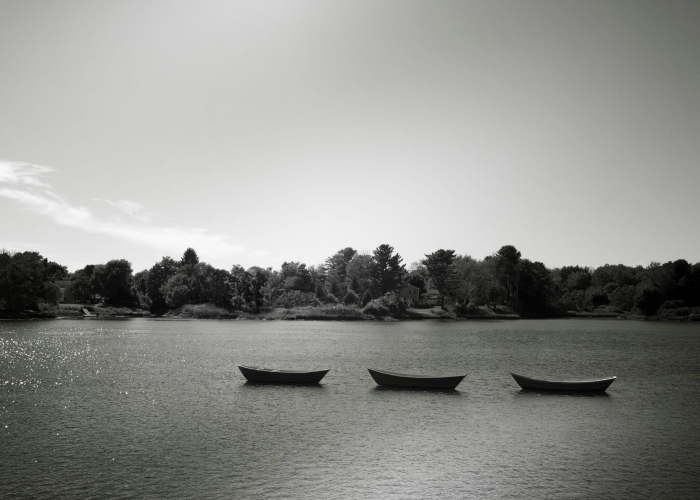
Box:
[0,244,700,316]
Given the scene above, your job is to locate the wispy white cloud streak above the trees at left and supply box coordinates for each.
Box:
[0,160,245,256]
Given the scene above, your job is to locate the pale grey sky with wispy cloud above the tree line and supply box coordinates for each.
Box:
[0,0,700,271]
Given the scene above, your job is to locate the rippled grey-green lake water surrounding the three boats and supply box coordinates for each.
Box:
[0,319,700,499]
